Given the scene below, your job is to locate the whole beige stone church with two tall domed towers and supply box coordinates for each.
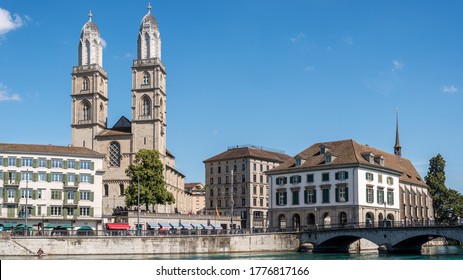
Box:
[71,5,188,214]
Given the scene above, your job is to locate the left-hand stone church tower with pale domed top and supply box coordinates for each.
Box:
[71,12,108,150]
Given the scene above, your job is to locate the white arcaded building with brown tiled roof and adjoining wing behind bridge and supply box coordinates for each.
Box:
[267,140,433,230]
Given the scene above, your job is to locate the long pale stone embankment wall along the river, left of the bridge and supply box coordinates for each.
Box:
[0,233,300,256]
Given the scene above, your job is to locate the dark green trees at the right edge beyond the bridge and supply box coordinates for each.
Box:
[424,154,463,223]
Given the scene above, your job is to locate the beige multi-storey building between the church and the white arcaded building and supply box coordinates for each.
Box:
[204,146,290,230]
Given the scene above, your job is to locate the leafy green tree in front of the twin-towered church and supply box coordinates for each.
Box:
[125,149,175,209]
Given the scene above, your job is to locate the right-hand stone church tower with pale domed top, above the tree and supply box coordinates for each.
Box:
[132,5,166,162]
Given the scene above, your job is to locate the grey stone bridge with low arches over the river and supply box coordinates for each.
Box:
[300,226,463,253]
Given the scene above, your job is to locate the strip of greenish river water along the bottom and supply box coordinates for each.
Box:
[0,246,463,260]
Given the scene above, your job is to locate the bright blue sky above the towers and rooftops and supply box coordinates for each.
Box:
[0,0,463,192]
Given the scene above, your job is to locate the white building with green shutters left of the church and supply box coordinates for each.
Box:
[0,144,104,229]
